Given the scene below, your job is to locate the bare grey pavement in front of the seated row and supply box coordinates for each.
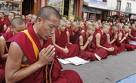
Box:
[62,50,136,83]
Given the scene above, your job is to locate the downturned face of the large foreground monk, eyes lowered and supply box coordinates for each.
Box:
[38,15,60,40]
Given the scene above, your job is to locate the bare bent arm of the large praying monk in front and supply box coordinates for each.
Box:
[5,42,53,83]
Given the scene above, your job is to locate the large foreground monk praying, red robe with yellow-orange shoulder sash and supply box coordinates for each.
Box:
[5,6,82,83]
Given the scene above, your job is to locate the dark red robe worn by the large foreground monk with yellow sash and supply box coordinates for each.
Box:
[14,27,82,83]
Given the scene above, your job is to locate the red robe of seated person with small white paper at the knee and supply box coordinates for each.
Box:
[79,32,96,61]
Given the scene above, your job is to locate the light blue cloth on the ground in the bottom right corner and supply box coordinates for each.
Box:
[116,74,136,83]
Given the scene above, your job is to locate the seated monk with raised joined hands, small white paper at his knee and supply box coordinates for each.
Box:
[79,22,100,61]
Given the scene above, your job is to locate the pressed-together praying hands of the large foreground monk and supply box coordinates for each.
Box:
[38,45,55,66]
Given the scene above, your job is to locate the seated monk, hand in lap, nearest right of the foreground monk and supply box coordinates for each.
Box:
[53,20,79,58]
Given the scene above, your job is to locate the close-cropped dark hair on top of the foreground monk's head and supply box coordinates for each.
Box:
[37,6,61,19]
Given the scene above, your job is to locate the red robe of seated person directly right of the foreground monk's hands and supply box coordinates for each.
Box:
[55,29,79,58]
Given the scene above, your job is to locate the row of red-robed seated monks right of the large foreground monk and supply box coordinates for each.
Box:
[53,20,136,61]
